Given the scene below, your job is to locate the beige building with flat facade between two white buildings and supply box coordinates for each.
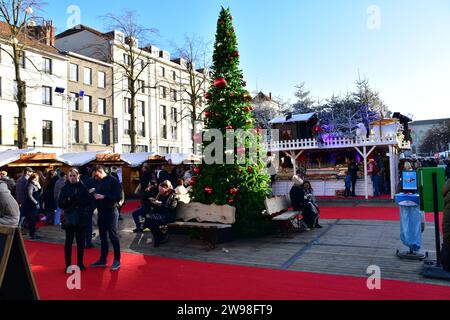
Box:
[64,52,114,152]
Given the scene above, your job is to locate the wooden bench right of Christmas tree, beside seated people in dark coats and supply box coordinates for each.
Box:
[264,196,302,235]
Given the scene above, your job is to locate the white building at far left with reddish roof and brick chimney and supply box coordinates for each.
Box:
[0,22,68,153]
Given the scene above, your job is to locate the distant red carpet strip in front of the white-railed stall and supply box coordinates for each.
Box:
[320,207,443,223]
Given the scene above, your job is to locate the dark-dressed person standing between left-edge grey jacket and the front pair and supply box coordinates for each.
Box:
[24,173,42,240]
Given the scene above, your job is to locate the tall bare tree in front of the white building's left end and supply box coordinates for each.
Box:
[100,10,157,153]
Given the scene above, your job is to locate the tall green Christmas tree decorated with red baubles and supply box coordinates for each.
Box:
[191,8,273,236]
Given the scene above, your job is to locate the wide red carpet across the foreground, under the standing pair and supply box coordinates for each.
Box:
[26,242,450,300]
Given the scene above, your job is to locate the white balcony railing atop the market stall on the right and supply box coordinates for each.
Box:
[264,135,411,152]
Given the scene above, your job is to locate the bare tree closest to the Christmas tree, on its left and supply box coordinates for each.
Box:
[171,35,211,151]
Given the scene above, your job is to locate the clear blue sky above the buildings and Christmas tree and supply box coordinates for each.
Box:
[45,0,450,120]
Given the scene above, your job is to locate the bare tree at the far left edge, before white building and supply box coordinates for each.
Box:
[0,0,44,149]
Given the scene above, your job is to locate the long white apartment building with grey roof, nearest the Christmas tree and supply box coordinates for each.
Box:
[56,25,206,154]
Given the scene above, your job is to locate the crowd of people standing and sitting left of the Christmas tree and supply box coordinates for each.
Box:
[0,163,194,272]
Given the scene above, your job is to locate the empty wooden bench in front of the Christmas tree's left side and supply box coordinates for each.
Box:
[167,202,236,248]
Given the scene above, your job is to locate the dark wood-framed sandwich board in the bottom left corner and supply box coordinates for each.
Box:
[0,226,39,300]
